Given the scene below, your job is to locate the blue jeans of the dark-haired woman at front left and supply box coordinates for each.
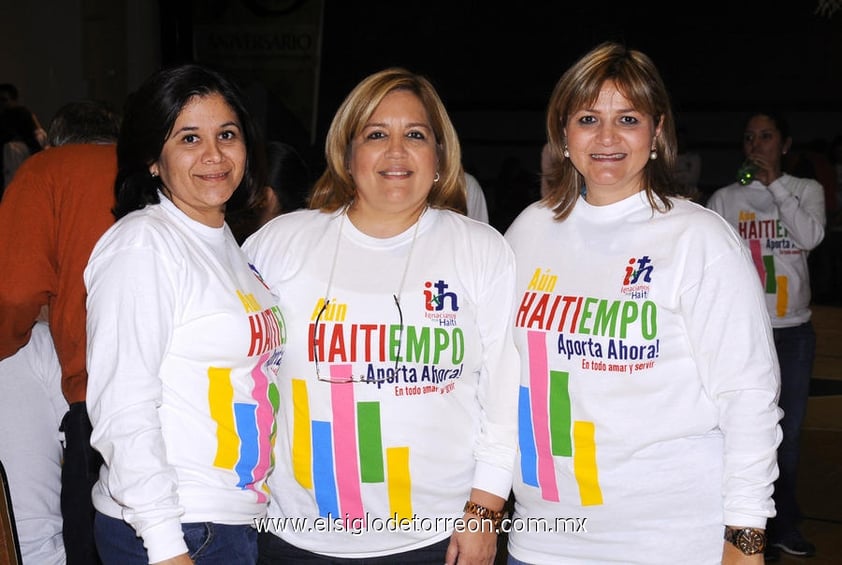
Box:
[94,512,257,565]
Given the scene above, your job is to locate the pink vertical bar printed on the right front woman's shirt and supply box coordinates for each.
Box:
[526,331,559,501]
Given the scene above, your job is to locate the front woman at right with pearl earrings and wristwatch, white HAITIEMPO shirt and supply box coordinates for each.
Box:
[505,42,780,565]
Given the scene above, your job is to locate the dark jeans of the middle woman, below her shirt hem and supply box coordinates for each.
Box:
[257,532,450,565]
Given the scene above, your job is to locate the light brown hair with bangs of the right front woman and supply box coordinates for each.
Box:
[544,42,679,219]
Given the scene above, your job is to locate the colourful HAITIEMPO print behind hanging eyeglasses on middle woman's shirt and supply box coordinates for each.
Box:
[290,286,465,521]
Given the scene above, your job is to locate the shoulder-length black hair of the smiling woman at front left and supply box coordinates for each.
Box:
[113,63,266,219]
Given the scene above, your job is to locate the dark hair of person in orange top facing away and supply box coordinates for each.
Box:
[47,100,120,147]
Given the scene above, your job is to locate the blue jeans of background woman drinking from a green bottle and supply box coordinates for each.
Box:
[768,322,816,541]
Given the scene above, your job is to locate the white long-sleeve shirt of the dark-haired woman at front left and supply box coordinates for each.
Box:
[85,196,285,562]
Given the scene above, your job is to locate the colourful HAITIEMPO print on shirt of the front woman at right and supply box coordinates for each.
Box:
[515,266,660,506]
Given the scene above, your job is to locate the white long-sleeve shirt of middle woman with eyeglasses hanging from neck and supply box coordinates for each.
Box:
[243,209,518,557]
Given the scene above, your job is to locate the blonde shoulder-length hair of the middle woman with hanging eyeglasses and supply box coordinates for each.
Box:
[308,67,467,214]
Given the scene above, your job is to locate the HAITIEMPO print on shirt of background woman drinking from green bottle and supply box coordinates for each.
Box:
[737,210,802,318]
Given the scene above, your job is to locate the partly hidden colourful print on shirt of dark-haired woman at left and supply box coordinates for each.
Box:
[208,290,286,502]
